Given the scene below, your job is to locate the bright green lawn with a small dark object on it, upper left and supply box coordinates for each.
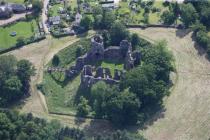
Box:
[0,20,38,50]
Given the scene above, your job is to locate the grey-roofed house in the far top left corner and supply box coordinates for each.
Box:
[0,4,12,18]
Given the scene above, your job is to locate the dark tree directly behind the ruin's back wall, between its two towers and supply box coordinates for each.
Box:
[110,21,129,45]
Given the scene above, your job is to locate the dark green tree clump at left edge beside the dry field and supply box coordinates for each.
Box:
[0,55,35,106]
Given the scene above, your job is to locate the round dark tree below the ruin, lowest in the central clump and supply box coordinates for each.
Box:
[107,90,140,126]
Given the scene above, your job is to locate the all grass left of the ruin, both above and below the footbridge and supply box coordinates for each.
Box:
[42,39,90,115]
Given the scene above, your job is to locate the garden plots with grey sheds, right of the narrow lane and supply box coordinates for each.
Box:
[47,0,77,37]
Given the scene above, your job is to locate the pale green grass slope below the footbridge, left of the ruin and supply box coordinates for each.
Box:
[42,73,80,115]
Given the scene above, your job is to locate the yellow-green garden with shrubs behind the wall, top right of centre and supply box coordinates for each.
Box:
[116,1,168,25]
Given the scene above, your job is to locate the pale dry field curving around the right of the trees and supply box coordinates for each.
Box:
[131,28,210,140]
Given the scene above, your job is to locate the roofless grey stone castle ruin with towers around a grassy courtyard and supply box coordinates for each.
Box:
[47,35,141,87]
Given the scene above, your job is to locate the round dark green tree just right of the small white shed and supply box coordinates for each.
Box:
[80,15,93,30]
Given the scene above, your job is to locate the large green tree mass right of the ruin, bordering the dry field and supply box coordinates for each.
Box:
[120,43,173,113]
